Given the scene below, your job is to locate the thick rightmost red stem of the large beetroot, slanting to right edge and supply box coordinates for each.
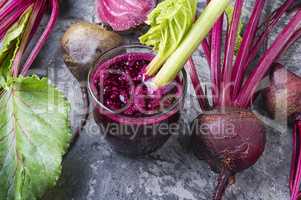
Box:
[235,10,301,107]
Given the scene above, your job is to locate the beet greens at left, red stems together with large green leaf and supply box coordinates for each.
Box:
[0,0,71,200]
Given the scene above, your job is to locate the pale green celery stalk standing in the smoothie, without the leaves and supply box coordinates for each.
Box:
[153,0,230,87]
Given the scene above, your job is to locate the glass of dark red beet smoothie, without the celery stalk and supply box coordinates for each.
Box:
[88,45,187,156]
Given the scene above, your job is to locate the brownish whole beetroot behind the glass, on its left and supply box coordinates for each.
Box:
[61,21,122,81]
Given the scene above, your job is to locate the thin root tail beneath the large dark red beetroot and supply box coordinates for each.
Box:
[212,168,233,200]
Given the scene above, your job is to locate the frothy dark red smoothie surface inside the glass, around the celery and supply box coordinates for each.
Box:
[93,53,181,117]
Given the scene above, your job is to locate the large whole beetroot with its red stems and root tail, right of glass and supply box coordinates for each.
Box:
[180,0,301,200]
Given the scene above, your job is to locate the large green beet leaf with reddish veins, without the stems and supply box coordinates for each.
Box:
[0,76,71,200]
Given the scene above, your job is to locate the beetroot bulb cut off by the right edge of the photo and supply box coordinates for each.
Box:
[263,64,301,122]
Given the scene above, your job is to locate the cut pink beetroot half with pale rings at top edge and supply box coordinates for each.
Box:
[96,0,156,31]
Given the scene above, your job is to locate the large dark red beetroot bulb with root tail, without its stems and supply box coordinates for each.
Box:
[193,108,266,200]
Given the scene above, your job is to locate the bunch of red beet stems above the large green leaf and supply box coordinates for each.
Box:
[0,0,59,77]
